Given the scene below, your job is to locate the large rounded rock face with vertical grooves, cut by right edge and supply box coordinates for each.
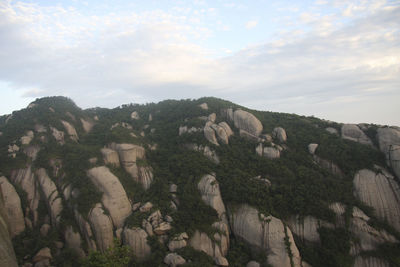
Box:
[353,169,400,231]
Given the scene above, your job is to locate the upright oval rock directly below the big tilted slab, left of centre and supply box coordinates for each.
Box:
[88,203,114,252]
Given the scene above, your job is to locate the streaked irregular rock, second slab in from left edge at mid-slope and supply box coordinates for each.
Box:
[11,166,40,225]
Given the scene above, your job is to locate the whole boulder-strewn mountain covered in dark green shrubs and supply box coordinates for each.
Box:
[0,97,400,267]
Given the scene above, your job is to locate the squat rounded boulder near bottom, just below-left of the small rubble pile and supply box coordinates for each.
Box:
[122,227,151,260]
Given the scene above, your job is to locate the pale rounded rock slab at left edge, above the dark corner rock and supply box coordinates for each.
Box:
[0,176,25,237]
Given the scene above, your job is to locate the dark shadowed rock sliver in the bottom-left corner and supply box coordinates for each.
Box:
[0,188,18,267]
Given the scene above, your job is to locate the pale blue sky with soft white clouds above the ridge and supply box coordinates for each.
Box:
[0,0,400,126]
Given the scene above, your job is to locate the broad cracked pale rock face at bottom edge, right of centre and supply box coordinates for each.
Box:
[230,204,301,267]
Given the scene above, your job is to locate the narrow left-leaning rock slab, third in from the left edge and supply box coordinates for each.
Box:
[36,168,63,226]
